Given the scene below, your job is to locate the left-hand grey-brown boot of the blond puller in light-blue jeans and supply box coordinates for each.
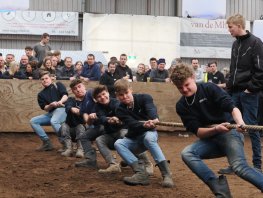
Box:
[123,161,149,186]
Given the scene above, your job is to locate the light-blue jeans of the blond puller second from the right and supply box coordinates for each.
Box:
[114,131,166,165]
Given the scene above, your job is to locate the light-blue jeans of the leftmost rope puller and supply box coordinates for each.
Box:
[30,107,67,140]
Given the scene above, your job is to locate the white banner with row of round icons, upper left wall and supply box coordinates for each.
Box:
[0,11,78,36]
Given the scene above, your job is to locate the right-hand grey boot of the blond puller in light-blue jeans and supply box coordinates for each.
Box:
[157,160,174,188]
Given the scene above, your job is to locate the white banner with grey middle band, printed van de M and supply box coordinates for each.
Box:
[180,18,250,59]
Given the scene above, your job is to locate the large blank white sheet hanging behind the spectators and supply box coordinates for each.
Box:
[82,13,180,68]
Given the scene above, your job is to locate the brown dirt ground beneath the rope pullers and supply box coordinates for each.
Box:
[0,132,263,198]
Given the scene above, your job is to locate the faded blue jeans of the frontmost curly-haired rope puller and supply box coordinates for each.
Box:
[181,130,263,190]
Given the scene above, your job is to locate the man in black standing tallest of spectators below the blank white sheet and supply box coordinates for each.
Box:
[116,54,133,81]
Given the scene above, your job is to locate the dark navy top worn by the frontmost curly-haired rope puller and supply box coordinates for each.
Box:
[176,83,235,134]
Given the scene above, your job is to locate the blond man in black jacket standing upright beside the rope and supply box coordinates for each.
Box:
[219,14,263,174]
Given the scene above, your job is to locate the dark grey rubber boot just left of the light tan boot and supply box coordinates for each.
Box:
[75,148,97,168]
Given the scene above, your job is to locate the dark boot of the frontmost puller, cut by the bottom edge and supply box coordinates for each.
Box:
[207,175,232,198]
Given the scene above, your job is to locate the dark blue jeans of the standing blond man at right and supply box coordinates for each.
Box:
[232,92,262,169]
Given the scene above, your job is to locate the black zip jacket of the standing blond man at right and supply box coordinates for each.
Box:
[227,31,263,92]
